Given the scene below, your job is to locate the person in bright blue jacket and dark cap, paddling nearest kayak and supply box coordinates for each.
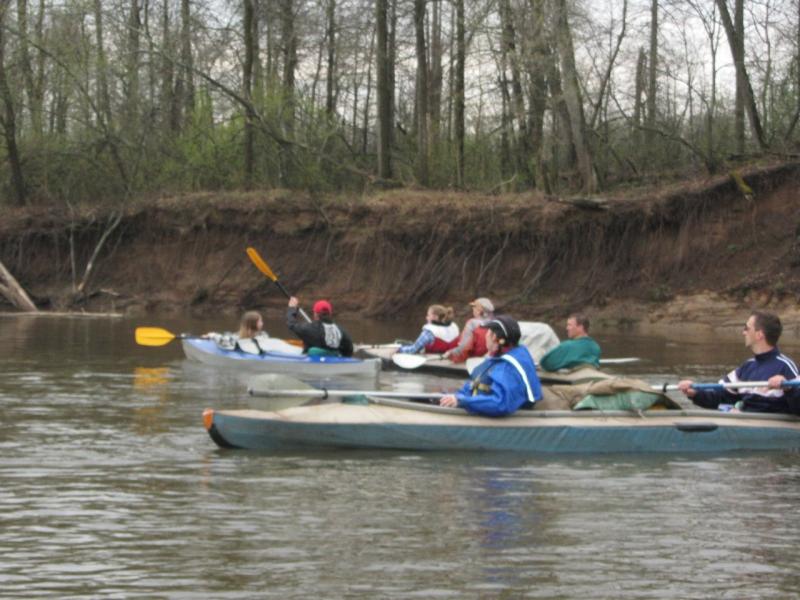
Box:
[439,315,542,417]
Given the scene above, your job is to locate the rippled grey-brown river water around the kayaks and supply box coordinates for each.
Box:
[0,316,800,599]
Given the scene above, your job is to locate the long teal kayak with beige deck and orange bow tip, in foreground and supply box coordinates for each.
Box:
[203,398,800,453]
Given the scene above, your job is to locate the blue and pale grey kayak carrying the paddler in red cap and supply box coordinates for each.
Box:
[182,338,381,377]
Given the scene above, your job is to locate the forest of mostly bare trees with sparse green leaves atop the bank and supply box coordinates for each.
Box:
[0,0,800,210]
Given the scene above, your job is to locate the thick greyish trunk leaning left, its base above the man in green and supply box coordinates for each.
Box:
[556,0,597,194]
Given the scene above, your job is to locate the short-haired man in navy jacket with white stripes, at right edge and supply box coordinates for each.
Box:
[678,310,800,414]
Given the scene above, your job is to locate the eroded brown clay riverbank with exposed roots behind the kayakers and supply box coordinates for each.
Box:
[0,163,800,335]
